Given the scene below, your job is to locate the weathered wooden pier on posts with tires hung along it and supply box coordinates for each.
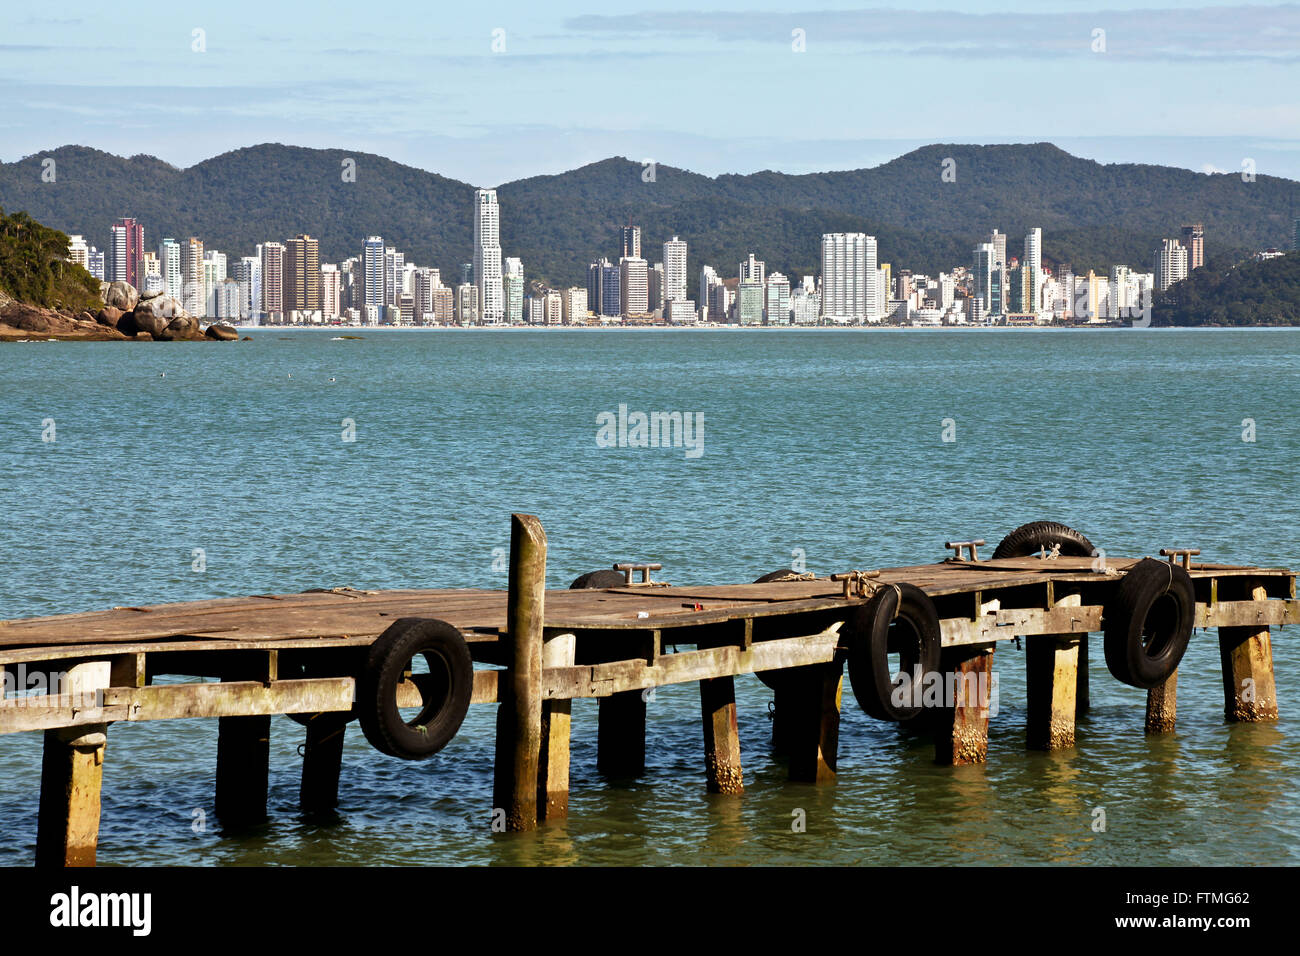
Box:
[0,515,1300,866]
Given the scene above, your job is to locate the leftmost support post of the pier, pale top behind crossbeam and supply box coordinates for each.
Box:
[36,661,111,866]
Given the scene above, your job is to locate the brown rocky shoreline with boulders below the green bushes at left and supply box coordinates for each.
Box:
[0,282,239,342]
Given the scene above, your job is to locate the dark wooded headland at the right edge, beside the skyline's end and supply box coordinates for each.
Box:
[1153,252,1300,325]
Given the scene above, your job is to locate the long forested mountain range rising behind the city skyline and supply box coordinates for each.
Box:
[0,143,1300,291]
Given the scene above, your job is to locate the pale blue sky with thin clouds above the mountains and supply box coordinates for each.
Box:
[0,0,1300,185]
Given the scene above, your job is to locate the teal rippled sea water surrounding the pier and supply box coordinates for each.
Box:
[0,329,1300,865]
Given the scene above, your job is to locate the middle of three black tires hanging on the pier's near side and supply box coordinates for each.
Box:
[840,584,943,722]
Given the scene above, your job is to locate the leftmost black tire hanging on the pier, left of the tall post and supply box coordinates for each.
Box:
[356,618,475,760]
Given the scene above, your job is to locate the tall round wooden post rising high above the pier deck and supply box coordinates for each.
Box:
[493,514,546,831]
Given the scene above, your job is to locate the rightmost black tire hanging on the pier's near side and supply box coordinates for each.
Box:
[1102,558,1196,691]
